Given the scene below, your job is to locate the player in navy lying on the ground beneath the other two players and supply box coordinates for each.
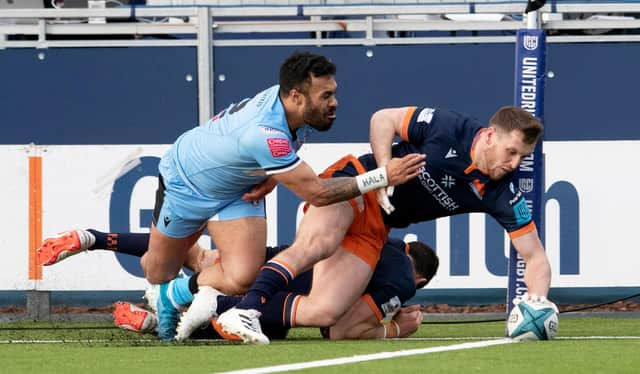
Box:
[40,229,439,340]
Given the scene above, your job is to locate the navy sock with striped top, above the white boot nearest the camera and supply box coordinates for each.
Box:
[237,260,296,310]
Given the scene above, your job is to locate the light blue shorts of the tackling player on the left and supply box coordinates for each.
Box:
[153,175,266,238]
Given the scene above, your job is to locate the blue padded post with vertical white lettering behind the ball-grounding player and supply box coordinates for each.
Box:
[507,29,546,315]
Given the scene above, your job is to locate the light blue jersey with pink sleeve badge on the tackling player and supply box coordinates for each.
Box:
[160,85,302,200]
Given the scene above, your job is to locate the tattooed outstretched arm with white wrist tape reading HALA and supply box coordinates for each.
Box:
[273,154,425,206]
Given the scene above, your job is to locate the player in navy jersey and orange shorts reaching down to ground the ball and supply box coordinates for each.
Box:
[219,107,551,344]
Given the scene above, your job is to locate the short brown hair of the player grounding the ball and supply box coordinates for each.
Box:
[489,106,544,144]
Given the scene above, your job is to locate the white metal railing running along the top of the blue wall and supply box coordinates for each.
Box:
[0,2,640,48]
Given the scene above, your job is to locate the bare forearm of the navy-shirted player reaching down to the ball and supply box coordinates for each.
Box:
[512,229,551,297]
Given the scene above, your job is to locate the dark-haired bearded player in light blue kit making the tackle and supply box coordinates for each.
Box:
[38,52,424,340]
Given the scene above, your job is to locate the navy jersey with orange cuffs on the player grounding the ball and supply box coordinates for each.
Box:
[359,107,535,239]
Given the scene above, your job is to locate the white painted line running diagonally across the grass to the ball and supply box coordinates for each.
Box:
[215,338,516,374]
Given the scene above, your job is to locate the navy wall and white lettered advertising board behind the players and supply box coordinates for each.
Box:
[0,43,640,305]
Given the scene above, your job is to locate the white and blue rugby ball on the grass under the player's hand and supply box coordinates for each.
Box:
[507,294,558,340]
